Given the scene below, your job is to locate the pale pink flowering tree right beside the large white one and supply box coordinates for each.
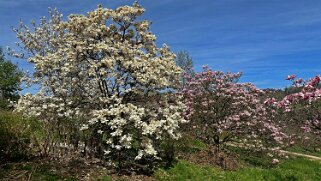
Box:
[182,66,286,152]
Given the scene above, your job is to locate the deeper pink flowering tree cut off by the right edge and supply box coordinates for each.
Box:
[268,75,321,147]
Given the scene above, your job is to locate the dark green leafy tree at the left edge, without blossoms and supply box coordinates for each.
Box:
[0,48,22,108]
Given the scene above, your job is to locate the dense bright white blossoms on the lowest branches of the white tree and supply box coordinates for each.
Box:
[82,94,185,159]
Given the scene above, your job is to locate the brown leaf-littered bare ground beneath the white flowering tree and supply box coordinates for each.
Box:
[0,158,155,181]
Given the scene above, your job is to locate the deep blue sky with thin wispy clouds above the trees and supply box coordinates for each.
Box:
[0,0,321,88]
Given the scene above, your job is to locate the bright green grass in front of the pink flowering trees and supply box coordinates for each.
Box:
[155,158,321,181]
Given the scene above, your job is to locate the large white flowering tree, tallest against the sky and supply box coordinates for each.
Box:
[15,3,184,170]
